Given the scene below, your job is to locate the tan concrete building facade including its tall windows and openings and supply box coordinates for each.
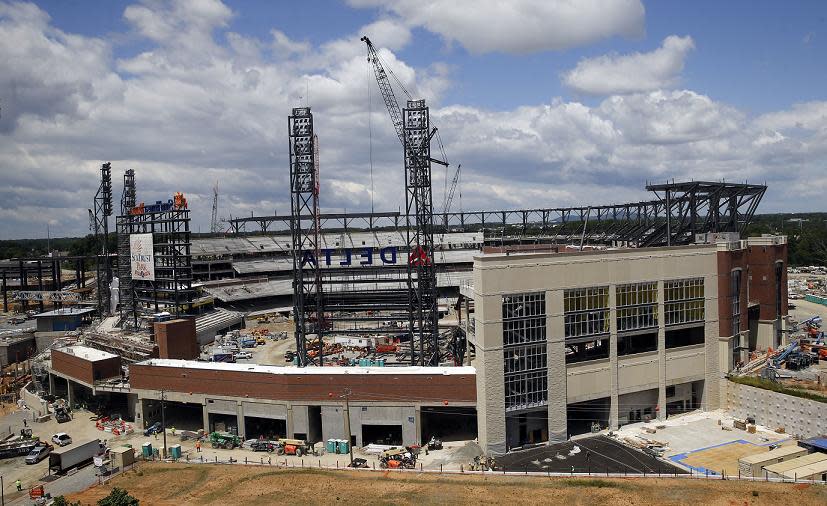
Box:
[469,245,720,454]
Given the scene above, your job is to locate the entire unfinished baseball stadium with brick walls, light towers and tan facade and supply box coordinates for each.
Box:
[0,38,804,462]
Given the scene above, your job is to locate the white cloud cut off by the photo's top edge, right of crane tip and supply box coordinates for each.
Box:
[349,0,645,53]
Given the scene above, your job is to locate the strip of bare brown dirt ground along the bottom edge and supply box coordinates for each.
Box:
[68,463,827,506]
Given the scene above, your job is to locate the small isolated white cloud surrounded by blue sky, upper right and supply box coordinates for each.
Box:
[563,35,695,95]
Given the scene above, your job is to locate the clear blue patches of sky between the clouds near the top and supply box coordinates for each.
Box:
[37,0,827,114]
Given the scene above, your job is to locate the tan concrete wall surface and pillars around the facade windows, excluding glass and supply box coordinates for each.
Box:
[474,245,721,450]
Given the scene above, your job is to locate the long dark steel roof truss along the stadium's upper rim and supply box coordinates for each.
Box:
[230,182,766,247]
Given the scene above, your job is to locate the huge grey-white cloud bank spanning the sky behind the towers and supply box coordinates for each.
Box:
[0,2,827,238]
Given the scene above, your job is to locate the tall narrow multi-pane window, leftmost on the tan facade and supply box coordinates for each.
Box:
[502,293,548,411]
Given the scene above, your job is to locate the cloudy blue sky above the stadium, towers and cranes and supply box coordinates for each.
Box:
[0,0,827,239]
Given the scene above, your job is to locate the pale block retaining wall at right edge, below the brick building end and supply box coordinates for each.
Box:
[724,380,827,438]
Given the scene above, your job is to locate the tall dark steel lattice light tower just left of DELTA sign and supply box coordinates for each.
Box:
[287,107,325,366]
